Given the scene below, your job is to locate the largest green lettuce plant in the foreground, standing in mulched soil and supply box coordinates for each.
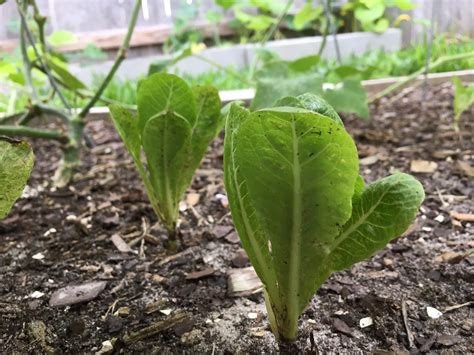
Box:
[224,94,424,341]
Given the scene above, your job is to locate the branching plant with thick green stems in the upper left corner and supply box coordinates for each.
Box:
[0,0,141,186]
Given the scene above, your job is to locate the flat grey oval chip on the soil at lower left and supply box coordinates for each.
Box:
[49,281,107,307]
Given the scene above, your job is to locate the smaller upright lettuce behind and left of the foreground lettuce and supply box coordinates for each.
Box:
[110,74,222,239]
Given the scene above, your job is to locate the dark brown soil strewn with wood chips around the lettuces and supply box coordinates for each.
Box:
[0,84,474,353]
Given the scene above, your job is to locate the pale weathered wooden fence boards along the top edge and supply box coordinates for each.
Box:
[0,0,474,49]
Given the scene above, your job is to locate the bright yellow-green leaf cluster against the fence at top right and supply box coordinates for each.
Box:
[342,0,416,32]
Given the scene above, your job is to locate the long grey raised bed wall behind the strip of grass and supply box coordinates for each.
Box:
[70,28,402,84]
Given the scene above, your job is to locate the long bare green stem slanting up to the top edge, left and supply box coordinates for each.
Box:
[79,0,142,118]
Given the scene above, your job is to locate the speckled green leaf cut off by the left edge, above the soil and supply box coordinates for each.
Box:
[0,136,34,219]
